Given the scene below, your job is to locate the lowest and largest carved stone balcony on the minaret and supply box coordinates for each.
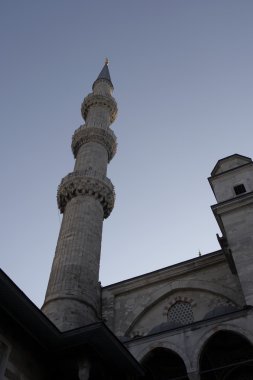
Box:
[57,170,115,218]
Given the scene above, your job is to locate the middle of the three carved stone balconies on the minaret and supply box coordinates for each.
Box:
[71,125,117,162]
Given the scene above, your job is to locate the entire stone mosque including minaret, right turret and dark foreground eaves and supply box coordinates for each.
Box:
[0,62,253,380]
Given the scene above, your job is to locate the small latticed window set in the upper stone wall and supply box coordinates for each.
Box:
[167,301,194,325]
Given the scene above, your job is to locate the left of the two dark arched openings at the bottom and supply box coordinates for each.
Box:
[141,347,188,380]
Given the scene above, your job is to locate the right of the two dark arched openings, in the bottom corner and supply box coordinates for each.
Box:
[200,331,253,380]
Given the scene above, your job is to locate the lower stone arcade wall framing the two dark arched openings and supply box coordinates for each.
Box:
[126,310,253,380]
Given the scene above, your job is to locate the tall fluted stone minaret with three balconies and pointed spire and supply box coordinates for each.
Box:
[42,59,117,331]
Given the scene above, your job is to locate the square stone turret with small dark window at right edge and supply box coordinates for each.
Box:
[209,154,253,305]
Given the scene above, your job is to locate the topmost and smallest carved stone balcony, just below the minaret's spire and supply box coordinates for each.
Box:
[81,94,118,123]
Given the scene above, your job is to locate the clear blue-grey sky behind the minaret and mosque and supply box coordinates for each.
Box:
[0,0,253,306]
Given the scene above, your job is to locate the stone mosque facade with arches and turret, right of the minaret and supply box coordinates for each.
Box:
[102,154,253,380]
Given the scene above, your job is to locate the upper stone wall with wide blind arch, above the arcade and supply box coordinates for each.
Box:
[102,251,245,337]
